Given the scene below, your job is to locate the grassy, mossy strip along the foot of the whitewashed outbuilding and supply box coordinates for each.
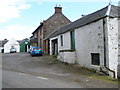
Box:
[47,56,118,84]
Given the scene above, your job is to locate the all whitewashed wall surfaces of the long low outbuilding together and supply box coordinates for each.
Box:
[51,18,120,76]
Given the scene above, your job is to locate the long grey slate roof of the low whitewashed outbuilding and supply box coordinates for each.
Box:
[45,5,120,39]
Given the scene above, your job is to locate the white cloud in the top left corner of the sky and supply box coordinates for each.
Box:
[0,0,31,23]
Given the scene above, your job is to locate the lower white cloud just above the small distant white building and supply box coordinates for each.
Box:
[0,25,34,40]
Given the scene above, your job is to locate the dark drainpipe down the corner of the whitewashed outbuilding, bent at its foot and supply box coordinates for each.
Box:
[103,19,115,78]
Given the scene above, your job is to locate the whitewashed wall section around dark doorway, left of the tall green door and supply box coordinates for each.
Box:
[50,32,76,64]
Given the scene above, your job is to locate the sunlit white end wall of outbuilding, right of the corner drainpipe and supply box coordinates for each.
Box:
[107,17,118,77]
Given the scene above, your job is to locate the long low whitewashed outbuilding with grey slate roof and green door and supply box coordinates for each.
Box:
[47,5,120,78]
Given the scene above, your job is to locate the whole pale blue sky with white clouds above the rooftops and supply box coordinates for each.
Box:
[0,0,118,40]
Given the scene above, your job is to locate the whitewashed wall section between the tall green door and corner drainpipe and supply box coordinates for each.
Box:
[75,20,104,69]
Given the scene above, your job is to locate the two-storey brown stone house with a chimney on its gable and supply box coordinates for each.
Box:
[30,6,71,54]
